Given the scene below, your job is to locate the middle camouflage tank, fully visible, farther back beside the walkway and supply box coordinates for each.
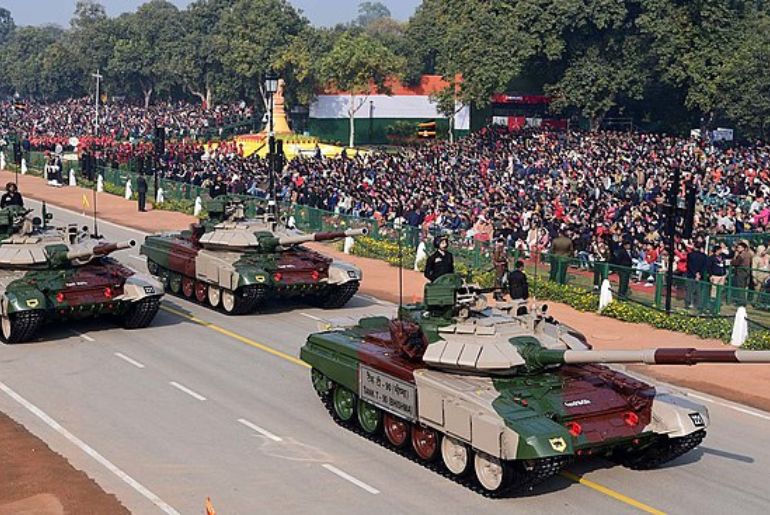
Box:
[140,197,366,315]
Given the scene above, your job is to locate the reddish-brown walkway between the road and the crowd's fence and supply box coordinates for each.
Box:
[0,172,770,411]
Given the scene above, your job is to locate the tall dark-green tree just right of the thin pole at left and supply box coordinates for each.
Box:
[108,0,183,107]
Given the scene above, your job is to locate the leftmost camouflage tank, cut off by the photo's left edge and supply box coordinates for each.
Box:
[0,206,163,343]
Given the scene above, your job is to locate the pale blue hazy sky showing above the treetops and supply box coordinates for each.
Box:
[0,0,421,27]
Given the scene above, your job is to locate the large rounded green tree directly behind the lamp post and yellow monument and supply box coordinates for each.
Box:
[214,0,308,114]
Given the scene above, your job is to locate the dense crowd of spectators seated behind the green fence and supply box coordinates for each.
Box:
[0,100,770,298]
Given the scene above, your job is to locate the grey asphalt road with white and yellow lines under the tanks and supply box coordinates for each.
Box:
[0,202,770,515]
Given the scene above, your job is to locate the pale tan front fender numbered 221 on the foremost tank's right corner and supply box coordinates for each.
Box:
[644,391,710,438]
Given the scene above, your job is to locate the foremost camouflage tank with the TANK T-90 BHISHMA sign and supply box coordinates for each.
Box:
[300,274,770,496]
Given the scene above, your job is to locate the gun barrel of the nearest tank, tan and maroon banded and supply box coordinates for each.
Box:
[525,348,770,365]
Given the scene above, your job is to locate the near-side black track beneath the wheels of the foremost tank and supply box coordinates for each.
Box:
[314,389,572,499]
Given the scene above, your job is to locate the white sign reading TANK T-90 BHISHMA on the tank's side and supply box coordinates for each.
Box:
[358,365,417,420]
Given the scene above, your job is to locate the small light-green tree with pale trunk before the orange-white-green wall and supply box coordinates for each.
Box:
[320,33,404,147]
